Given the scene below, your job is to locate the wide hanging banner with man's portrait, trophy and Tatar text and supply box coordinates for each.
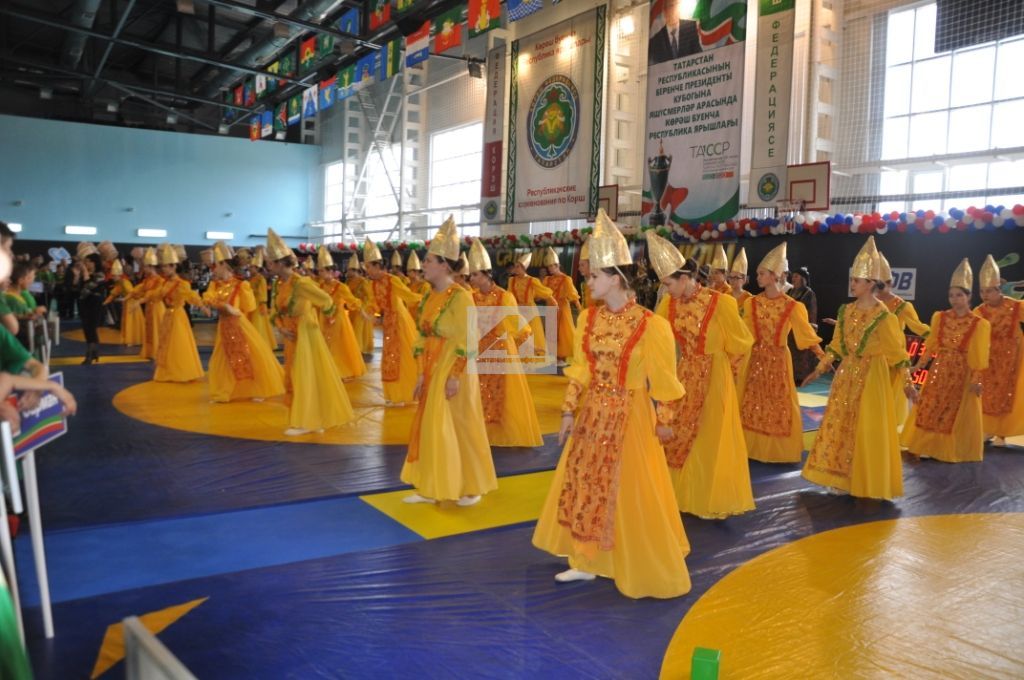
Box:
[641,0,746,226]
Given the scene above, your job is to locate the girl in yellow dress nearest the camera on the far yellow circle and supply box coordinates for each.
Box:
[266,229,355,436]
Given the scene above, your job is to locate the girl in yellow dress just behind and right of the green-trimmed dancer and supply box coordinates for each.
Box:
[468,239,544,447]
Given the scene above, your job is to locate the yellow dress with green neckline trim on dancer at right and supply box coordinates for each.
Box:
[803,303,910,500]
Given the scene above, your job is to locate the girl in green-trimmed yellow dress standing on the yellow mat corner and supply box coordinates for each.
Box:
[401,216,498,506]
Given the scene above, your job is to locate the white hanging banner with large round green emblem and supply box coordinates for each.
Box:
[505,5,605,222]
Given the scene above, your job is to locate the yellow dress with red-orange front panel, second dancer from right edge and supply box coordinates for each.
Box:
[900,309,991,463]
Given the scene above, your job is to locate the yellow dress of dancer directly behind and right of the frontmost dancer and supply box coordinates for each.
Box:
[657,287,754,519]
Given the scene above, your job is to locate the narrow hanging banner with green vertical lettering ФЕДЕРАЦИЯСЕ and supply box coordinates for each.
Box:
[746,0,796,208]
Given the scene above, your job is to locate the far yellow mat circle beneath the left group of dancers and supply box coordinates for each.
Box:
[116,366,566,444]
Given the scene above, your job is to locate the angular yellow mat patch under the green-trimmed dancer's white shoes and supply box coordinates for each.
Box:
[359,471,555,539]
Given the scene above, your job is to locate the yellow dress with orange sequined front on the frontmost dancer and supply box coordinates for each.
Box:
[534,302,690,598]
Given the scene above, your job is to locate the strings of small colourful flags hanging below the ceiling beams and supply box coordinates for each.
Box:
[235,0,558,140]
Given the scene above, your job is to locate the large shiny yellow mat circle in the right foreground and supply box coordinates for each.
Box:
[660,514,1024,679]
